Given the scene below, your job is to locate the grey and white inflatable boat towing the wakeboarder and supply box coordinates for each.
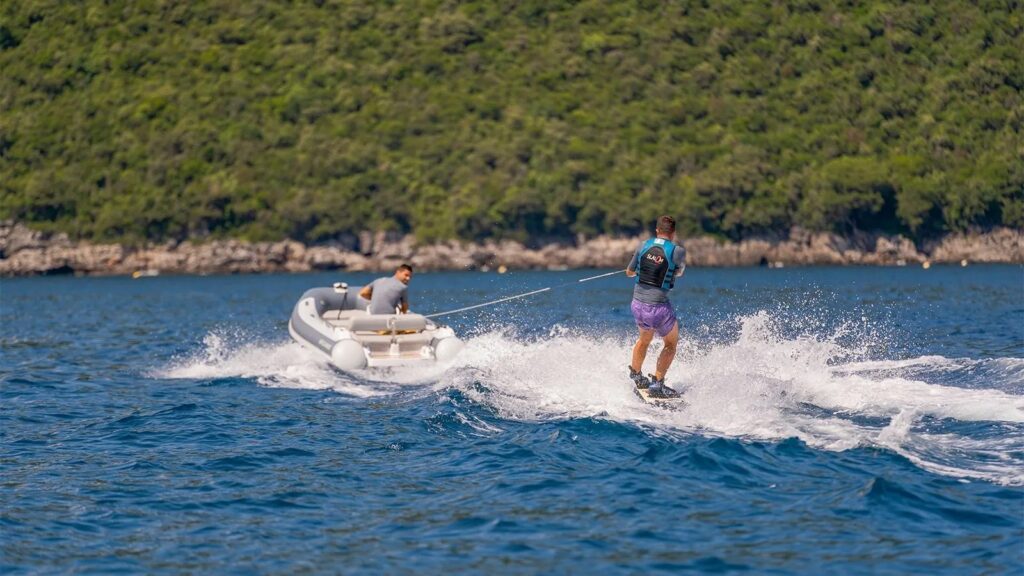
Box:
[288,282,462,370]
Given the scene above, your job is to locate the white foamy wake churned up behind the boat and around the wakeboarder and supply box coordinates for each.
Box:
[157,313,1024,485]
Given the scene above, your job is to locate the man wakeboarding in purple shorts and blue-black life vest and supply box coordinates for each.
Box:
[626,216,686,398]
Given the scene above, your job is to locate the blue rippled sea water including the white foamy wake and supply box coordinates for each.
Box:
[0,265,1024,574]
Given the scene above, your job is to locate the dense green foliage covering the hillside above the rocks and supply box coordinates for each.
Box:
[0,0,1024,241]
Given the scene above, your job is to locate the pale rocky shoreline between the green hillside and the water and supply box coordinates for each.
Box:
[0,221,1024,277]
